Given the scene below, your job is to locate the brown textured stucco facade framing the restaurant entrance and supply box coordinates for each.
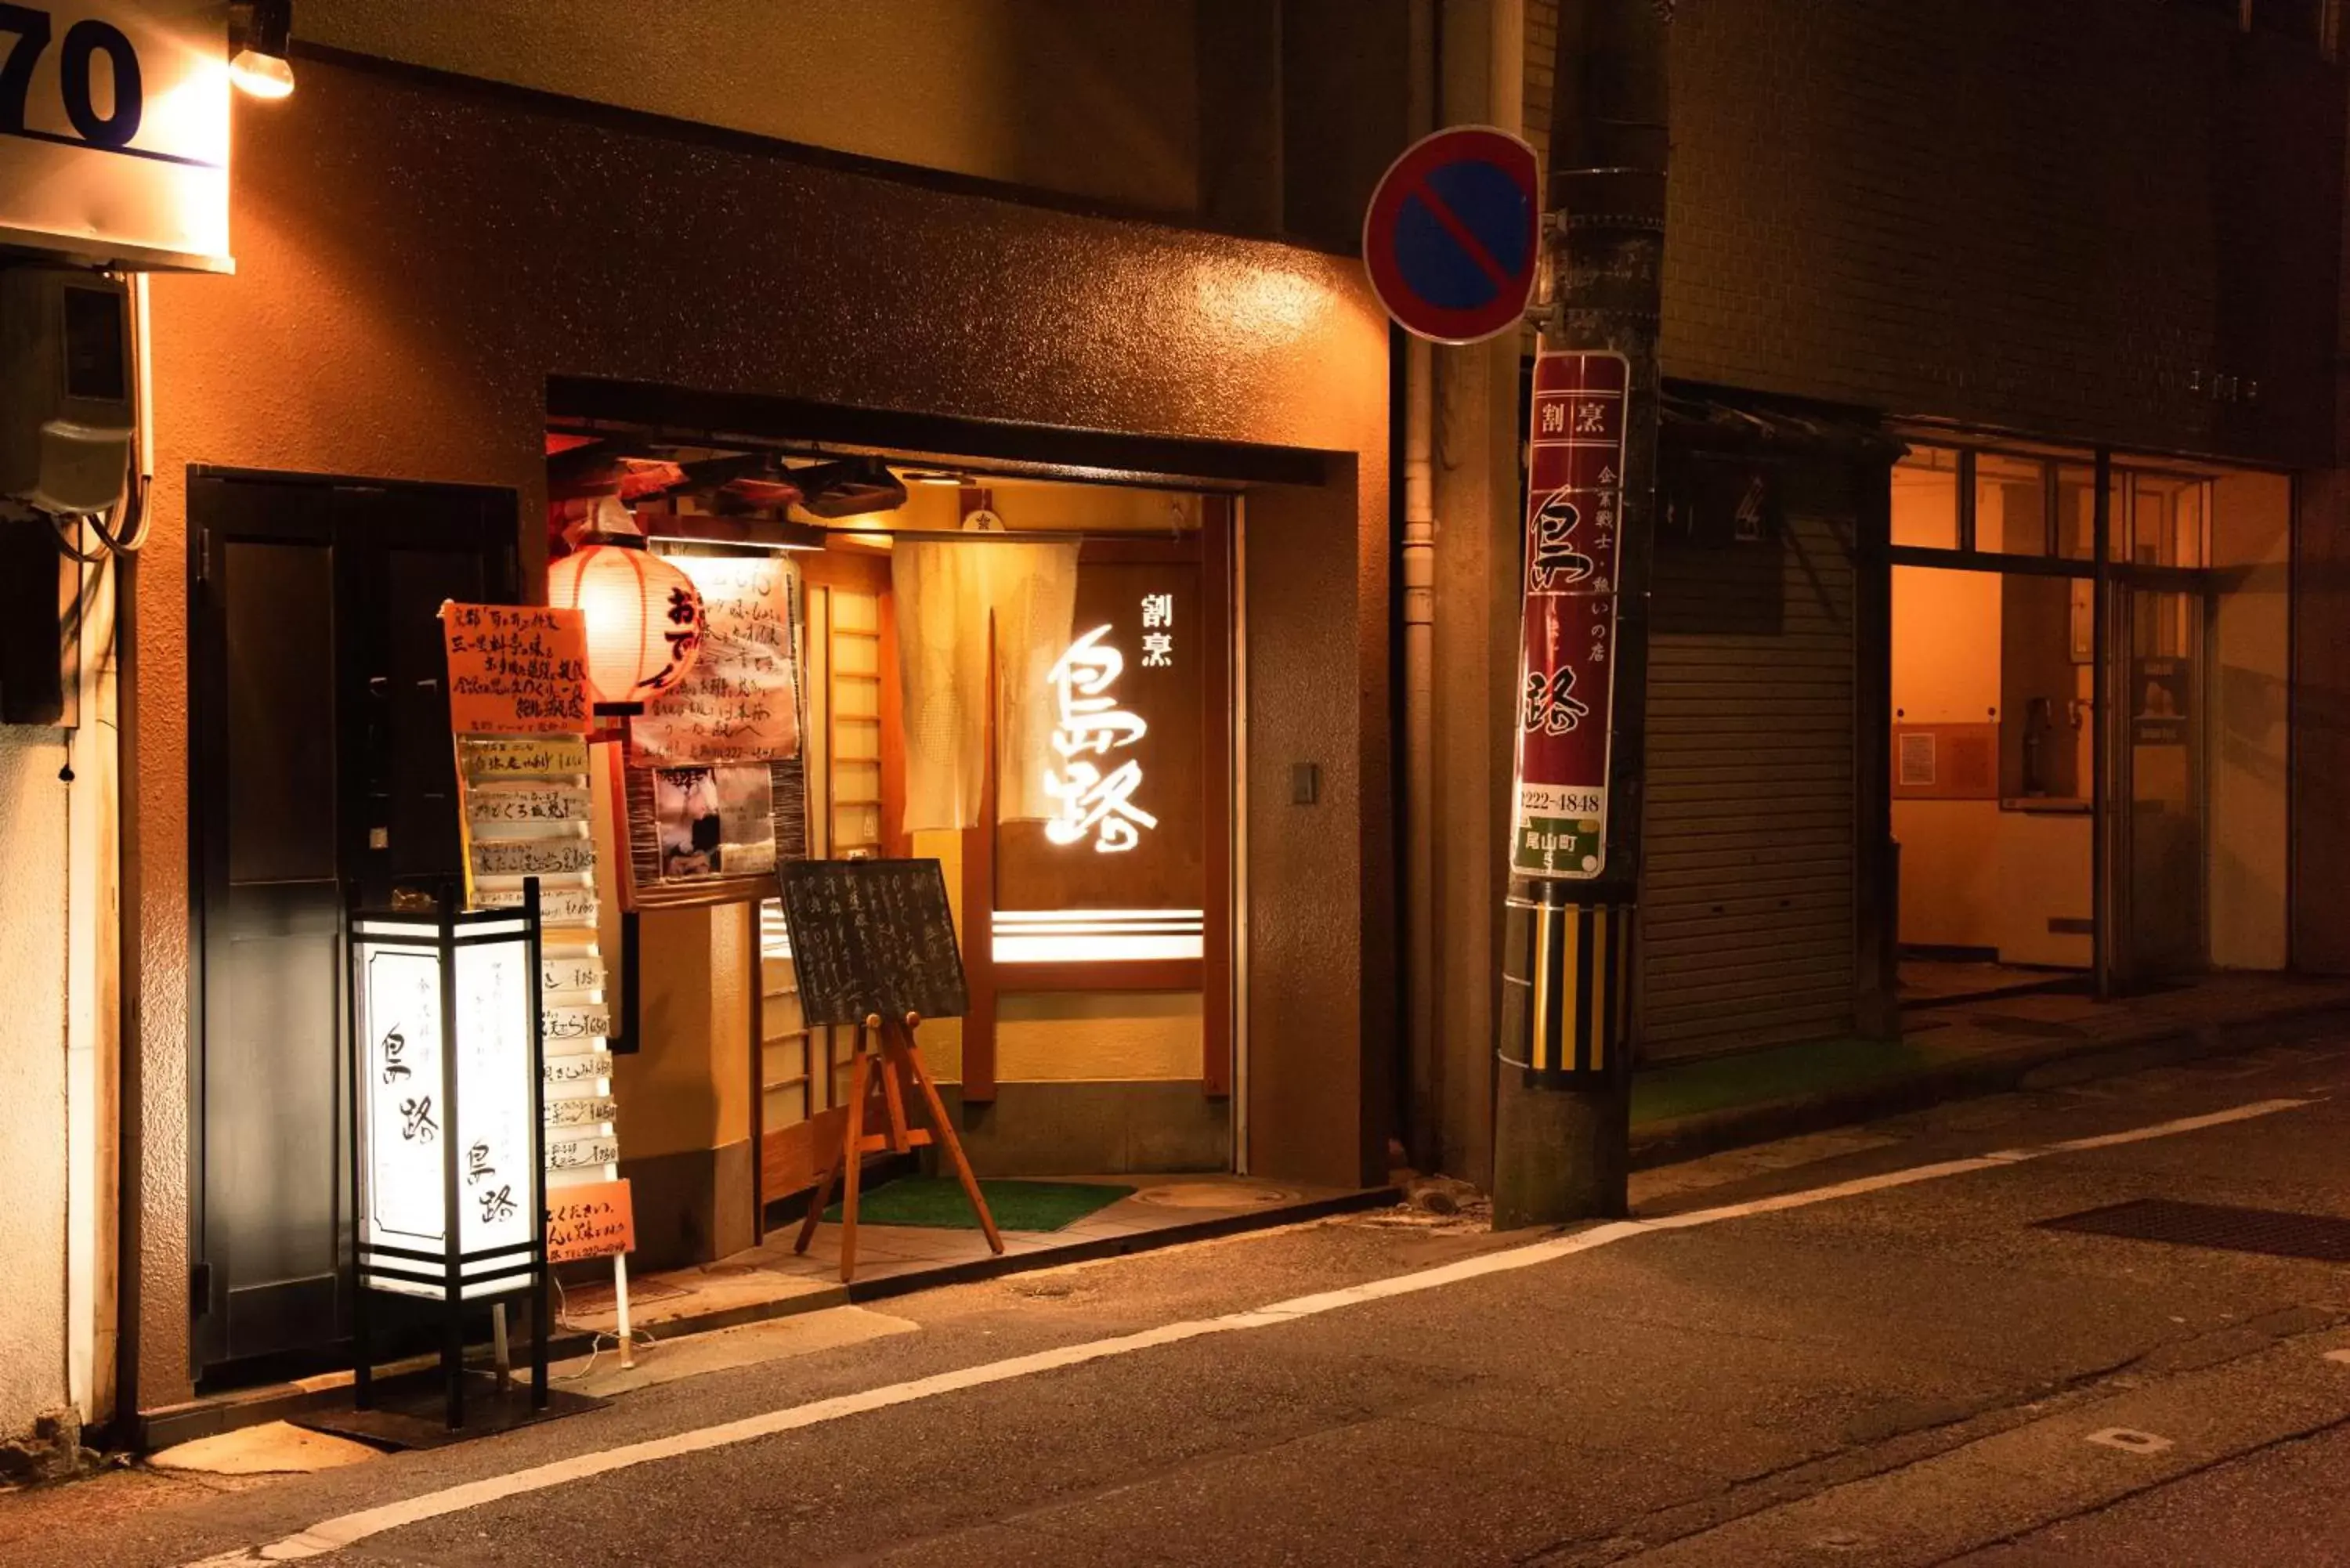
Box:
[136,61,1386,1406]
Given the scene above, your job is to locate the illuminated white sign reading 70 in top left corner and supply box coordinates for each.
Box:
[0,0,233,273]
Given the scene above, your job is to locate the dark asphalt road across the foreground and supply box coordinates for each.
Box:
[13,1037,2350,1568]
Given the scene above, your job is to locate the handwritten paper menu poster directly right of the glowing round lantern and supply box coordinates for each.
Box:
[627,555,799,768]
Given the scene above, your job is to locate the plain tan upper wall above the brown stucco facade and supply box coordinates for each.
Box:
[296,0,1201,214]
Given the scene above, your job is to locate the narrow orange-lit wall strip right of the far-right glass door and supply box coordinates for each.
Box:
[2204,475,2284,969]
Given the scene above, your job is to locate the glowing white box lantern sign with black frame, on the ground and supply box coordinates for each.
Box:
[350,910,545,1300]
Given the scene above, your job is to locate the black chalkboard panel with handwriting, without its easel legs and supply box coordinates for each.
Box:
[783,861,971,1025]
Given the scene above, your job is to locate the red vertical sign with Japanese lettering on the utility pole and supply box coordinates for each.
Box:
[1509,352,1631,882]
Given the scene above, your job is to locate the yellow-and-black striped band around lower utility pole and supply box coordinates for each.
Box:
[1504,898,1633,1089]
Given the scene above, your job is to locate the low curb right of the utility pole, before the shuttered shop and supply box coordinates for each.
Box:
[1631,999,2350,1171]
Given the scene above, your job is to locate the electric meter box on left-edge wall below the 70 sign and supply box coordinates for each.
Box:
[0,266,139,512]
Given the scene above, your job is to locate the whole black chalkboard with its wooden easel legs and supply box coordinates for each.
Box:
[778,861,1003,1281]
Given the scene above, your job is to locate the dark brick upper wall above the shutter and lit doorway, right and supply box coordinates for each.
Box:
[1525,0,2345,465]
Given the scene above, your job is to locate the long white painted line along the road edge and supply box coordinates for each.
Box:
[186,1100,2310,1568]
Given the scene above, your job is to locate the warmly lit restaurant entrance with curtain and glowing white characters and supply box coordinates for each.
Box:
[548,416,1243,1267]
